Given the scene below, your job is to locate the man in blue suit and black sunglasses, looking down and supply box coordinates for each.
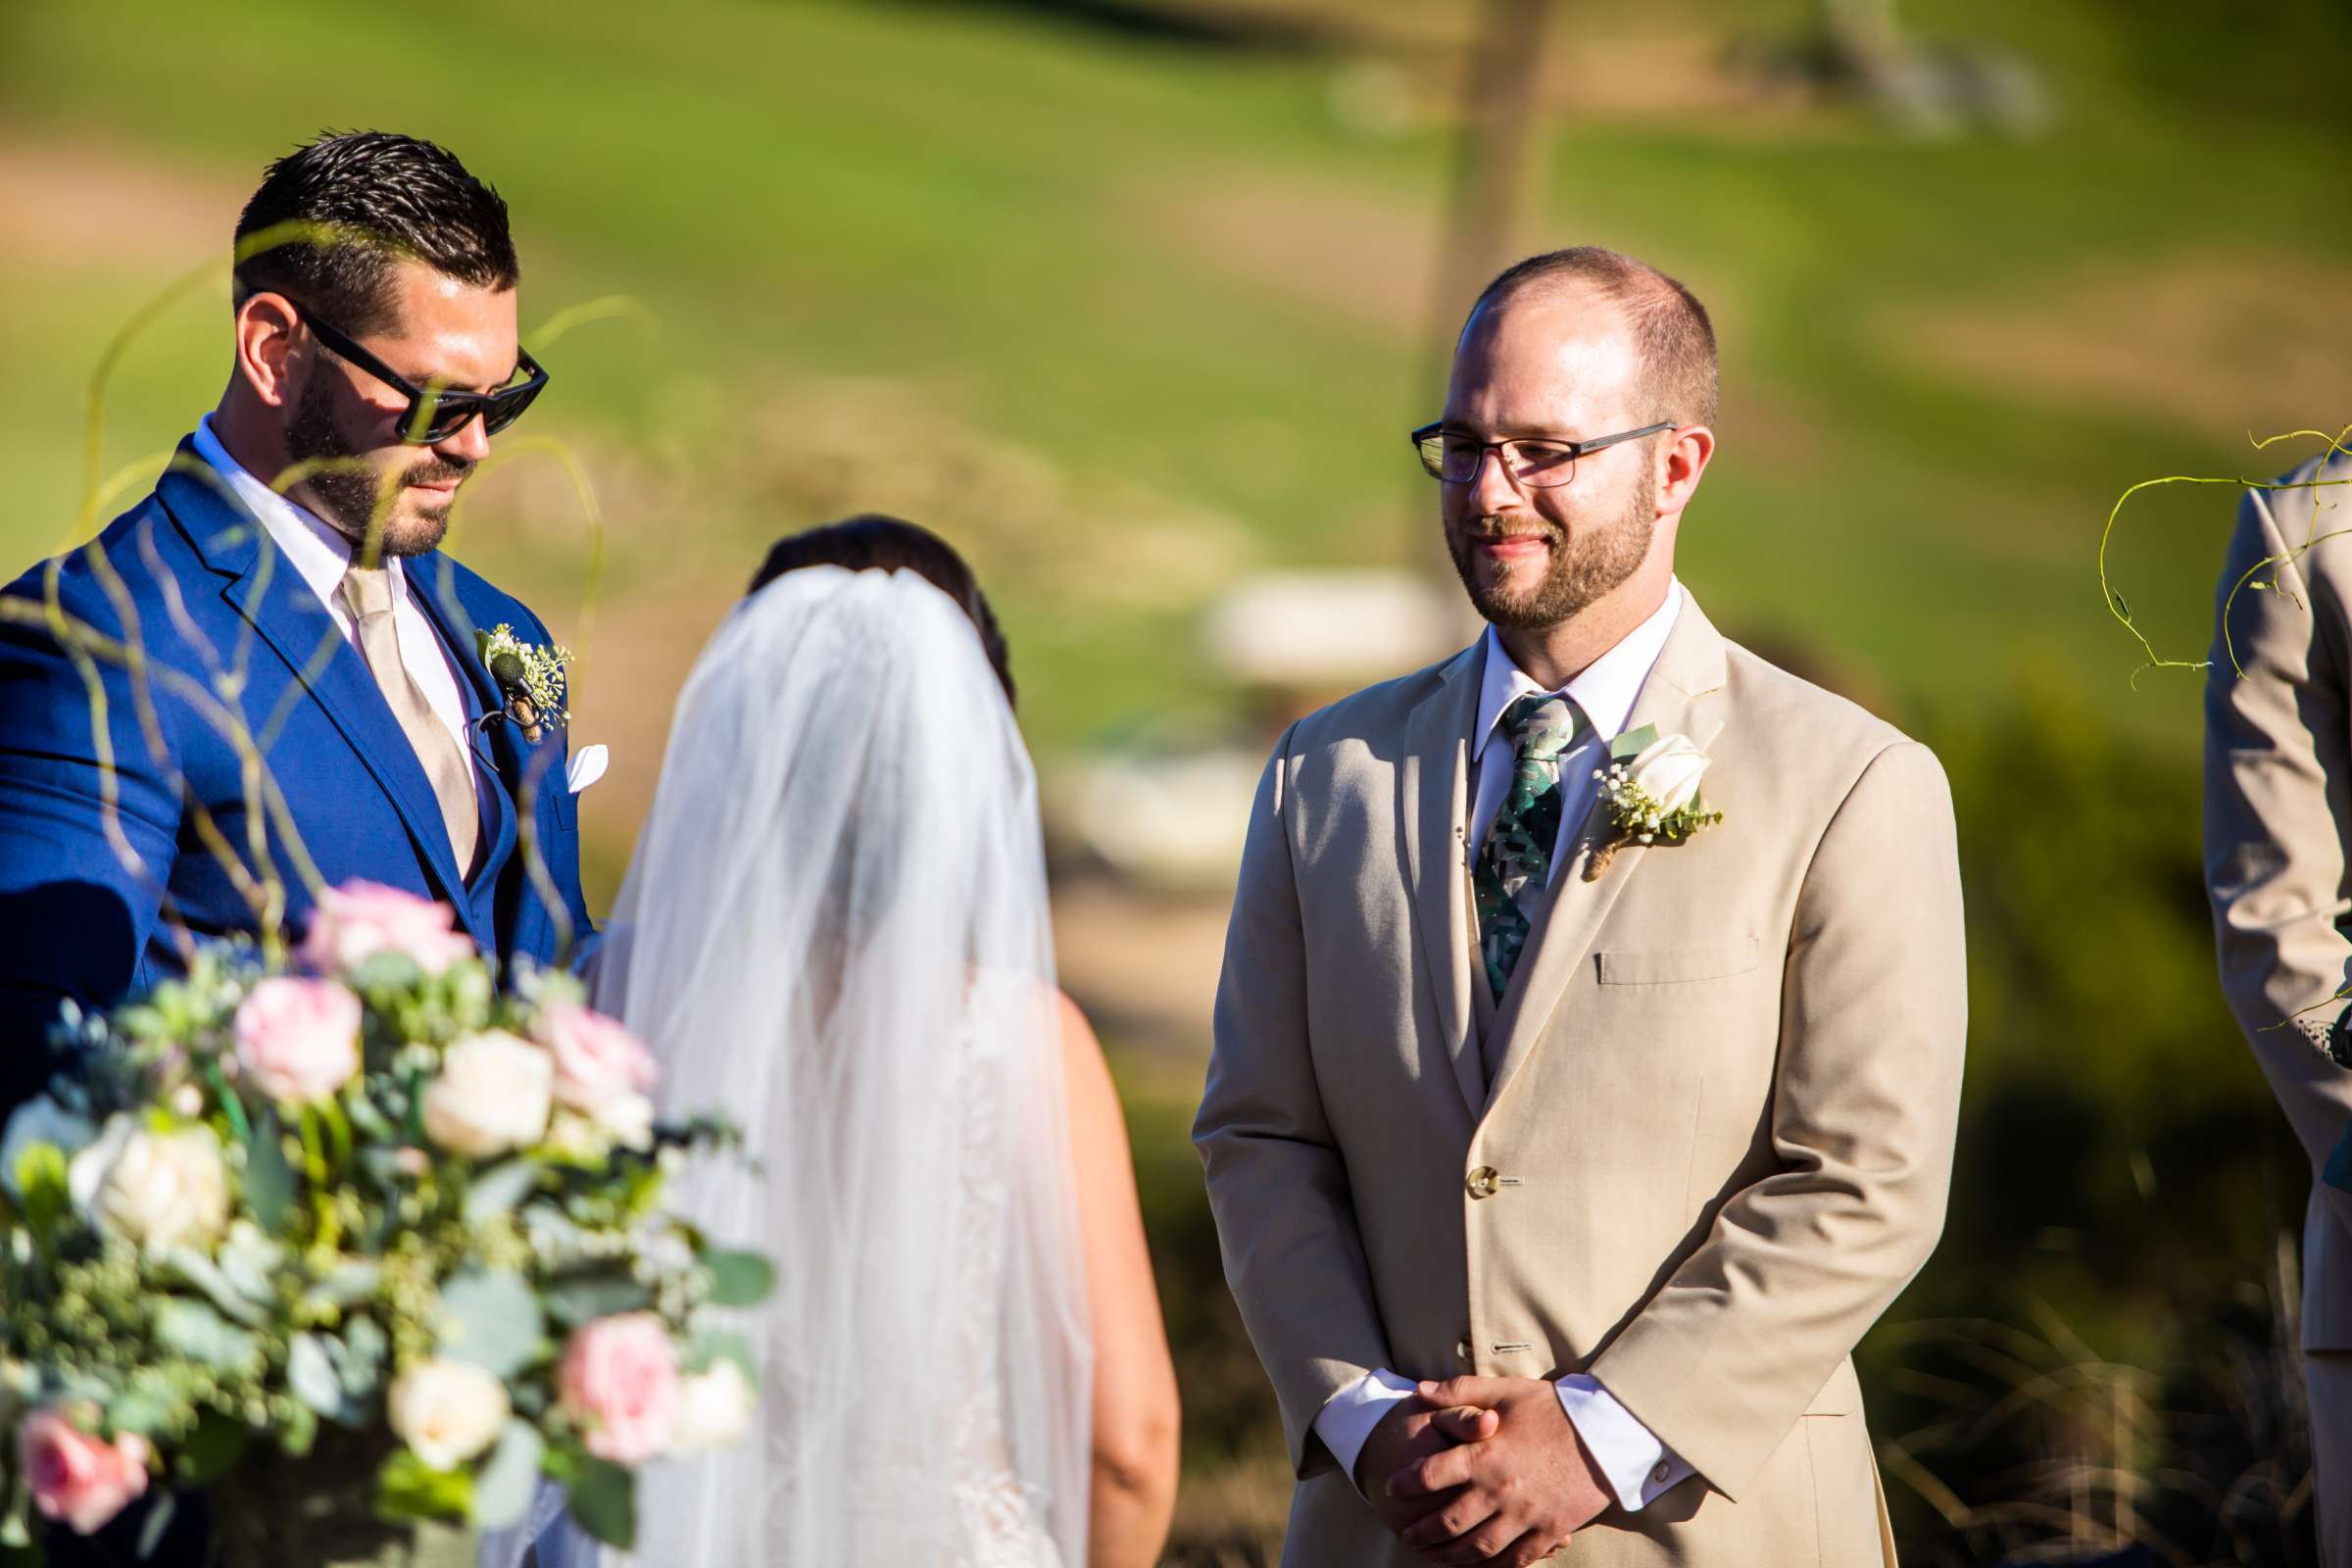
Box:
[0,131,593,1114]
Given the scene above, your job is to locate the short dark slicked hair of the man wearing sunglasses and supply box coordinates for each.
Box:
[235,131,522,336]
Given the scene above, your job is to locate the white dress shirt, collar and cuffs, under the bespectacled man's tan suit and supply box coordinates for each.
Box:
[1315,581,1691,1511]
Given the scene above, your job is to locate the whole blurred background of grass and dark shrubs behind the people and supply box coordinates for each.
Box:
[0,0,2352,1563]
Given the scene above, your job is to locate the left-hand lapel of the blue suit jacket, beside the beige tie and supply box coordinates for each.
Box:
[155,453,486,945]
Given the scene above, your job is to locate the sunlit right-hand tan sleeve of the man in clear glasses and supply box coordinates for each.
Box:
[1590,741,1969,1497]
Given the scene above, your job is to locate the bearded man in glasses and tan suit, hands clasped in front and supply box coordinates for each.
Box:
[1195,247,1966,1568]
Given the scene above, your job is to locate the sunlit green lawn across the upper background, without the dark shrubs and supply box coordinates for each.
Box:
[0,2,2352,761]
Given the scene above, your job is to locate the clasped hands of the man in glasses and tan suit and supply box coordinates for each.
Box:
[1357,1378,1611,1568]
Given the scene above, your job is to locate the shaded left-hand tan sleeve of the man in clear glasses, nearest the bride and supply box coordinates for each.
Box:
[1193,733,1390,1476]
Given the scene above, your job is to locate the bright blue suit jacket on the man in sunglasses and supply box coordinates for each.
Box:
[0,442,593,1112]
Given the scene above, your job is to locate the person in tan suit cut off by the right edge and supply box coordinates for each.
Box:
[2204,441,2352,1568]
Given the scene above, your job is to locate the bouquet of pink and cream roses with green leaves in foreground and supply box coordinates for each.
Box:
[0,884,774,1563]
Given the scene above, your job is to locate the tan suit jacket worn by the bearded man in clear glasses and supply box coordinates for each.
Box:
[1195,594,1966,1568]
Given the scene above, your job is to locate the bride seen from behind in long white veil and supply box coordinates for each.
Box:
[557,517,1176,1568]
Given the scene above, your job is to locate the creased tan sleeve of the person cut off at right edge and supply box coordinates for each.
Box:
[2204,489,2352,1175]
